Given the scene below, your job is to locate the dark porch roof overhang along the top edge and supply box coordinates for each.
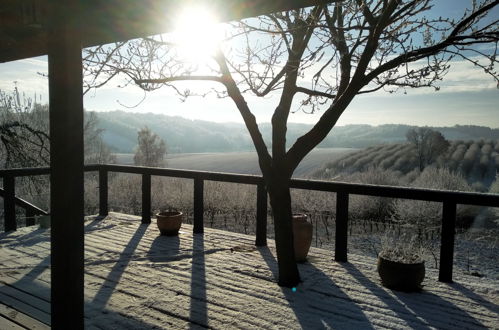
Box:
[0,0,331,63]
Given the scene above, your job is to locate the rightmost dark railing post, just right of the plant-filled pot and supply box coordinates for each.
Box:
[438,201,456,283]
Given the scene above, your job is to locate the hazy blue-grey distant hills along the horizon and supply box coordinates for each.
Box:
[96,111,499,153]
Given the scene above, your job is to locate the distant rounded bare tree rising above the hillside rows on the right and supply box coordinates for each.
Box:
[406,127,450,172]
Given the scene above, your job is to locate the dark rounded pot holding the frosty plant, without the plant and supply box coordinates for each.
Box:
[378,256,425,292]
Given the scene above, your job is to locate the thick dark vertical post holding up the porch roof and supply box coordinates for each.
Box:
[47,0,84,329]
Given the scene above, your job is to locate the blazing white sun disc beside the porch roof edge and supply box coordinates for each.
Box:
[173,7,224,64]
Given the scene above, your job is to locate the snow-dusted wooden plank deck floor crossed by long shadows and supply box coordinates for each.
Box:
[0,213,499,329]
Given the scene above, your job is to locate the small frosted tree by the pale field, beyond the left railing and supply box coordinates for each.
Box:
[133,127,166,167]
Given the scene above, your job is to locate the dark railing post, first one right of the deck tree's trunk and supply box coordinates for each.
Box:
[334,192,348,262]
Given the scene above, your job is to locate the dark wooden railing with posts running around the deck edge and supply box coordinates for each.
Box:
[0,164,499,282]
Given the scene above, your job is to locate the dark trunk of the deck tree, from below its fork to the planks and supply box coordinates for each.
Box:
[266,171,300,288]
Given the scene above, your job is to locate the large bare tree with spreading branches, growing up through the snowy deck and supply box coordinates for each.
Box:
[85,0,499,287]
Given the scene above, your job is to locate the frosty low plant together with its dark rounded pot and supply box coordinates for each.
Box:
[377,229,425,292]
